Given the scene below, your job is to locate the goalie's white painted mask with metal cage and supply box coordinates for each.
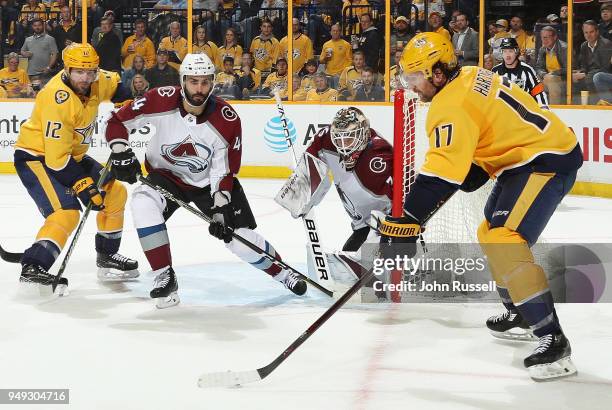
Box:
[330,107,370,170]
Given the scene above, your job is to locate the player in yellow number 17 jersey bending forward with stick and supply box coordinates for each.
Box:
[381,33,582,380]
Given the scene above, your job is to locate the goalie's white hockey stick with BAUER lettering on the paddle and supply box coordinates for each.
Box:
[274,91,332,287]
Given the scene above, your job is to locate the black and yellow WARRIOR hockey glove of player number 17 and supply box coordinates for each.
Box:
[378,215,421,259]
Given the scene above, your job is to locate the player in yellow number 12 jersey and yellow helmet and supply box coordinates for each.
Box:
[14,43,138,292]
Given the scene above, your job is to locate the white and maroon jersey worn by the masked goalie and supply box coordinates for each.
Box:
[307,127,393,230]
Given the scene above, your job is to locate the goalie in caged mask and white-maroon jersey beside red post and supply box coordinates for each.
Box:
[276,107,393,252]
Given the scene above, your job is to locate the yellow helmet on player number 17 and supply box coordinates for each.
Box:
[399,32,457,79]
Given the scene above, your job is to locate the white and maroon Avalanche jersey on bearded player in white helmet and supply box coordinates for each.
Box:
[106,87,242,192]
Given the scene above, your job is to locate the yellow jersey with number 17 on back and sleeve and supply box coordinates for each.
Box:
[421,67,578,184]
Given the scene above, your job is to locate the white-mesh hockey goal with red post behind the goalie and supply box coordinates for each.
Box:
[389,90,493,302]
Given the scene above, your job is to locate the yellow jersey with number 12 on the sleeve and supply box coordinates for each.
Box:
[15,70,120,171]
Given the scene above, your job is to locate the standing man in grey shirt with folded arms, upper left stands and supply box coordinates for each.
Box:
[21,19,57,84]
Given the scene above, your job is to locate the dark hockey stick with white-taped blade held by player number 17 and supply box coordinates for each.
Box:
[198,269,374,387]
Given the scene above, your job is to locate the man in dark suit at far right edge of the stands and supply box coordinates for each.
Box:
[572,20,612,102]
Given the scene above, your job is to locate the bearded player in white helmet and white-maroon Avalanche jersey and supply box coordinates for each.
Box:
[106,54,306,308]
